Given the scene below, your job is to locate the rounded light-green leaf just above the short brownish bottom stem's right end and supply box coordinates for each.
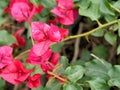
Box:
[65,65,85,83]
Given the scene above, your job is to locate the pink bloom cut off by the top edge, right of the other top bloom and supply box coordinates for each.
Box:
[51,0,75,25]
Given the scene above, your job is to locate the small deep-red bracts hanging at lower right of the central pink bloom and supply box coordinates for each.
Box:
[41,53,60,73]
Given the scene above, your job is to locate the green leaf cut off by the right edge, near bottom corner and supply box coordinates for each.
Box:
[108,65,120,88]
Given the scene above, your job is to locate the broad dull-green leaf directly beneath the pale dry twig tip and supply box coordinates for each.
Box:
[85,59,112,80]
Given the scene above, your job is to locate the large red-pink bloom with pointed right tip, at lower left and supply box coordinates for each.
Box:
[0,60,32,84]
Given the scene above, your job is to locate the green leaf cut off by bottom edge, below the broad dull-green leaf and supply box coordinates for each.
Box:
[87,77,109,90]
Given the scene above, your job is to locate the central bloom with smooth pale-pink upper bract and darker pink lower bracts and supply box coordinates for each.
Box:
[26,41,52,65]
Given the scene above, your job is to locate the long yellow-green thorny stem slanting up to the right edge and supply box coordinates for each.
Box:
[63,20,119,41]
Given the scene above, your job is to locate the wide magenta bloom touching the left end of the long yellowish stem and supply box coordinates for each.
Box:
[32,22,68,42]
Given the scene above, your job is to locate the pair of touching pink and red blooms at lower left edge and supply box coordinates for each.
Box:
[0,46,32,87]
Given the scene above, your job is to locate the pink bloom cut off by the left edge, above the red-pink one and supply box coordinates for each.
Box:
[0,46,13,69]
